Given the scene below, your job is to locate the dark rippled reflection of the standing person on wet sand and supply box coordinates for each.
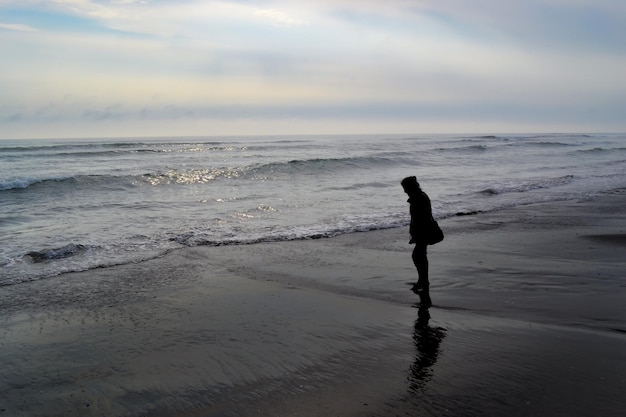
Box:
[409,307,446,392]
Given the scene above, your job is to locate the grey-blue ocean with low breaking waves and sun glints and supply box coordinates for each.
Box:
[0,134,626,286]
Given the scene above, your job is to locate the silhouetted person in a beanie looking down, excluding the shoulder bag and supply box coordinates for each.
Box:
[401,177,433,296]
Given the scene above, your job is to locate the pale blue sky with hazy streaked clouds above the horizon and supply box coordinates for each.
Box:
[0,0,626,139]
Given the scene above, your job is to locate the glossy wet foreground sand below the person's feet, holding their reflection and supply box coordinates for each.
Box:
[0,276,626,417]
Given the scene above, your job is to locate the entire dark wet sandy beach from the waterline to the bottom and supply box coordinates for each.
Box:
[0,193,626,417]
